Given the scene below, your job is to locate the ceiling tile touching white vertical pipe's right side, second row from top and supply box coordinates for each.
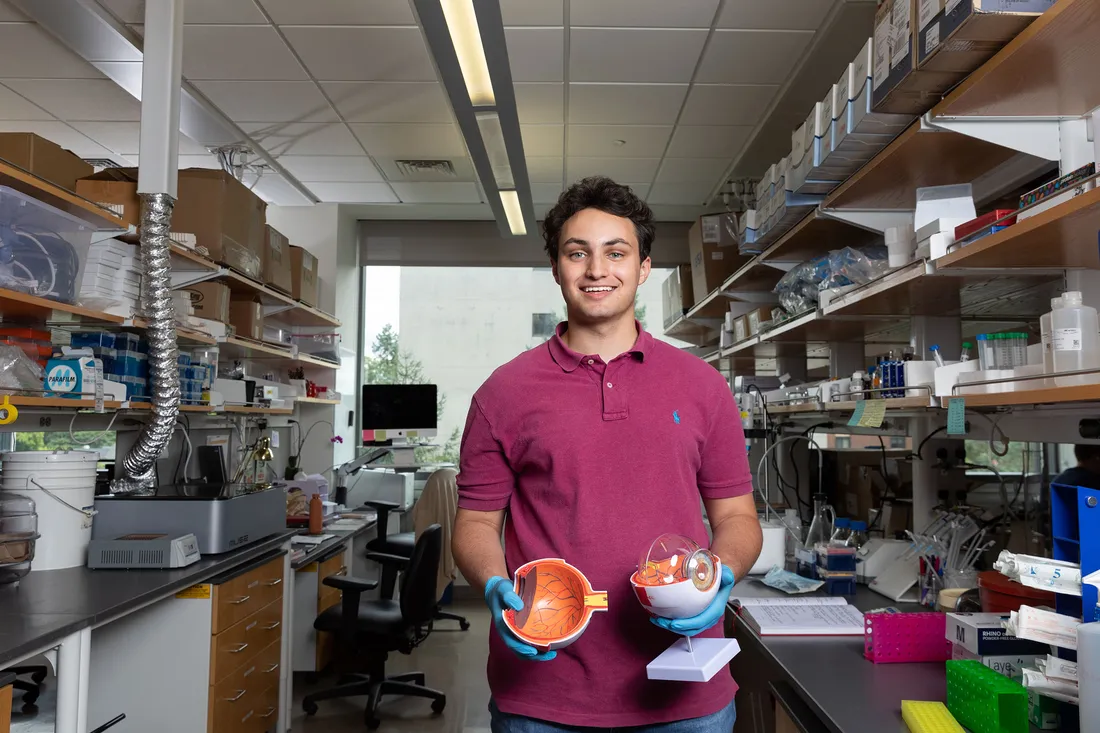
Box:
[184,25,309,81]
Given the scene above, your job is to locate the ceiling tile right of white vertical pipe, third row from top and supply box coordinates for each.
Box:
[195,81,339,122]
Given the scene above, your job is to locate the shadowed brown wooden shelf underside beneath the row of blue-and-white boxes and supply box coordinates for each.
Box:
[821,120,1016,211]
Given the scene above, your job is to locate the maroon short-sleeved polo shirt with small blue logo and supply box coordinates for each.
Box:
[459,324,752,727]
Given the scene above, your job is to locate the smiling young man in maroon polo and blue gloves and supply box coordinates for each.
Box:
[453,178,762,733]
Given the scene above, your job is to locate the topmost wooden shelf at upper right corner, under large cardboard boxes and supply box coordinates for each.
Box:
[932,0,1100,119]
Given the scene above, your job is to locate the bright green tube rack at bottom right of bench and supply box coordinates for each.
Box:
[946,659,1029,733]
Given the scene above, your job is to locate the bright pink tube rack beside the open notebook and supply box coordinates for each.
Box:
[864,613,952,664]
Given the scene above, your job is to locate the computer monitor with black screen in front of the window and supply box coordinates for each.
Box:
[362,384,439,444]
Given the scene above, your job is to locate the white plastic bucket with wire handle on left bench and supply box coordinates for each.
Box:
[0,450,99,572]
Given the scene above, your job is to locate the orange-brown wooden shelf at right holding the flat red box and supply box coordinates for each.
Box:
[936,186,1100,268]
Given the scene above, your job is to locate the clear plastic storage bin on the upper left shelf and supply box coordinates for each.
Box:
[0,186,95,303]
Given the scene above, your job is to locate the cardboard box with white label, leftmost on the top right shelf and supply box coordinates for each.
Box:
[871,0,957,116]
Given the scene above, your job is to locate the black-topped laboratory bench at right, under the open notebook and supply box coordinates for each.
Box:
[726,578,1038,733]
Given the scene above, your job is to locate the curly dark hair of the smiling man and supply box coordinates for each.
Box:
[542,176,656,262]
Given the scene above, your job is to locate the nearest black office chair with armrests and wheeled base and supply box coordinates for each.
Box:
[301,524,447,731]
